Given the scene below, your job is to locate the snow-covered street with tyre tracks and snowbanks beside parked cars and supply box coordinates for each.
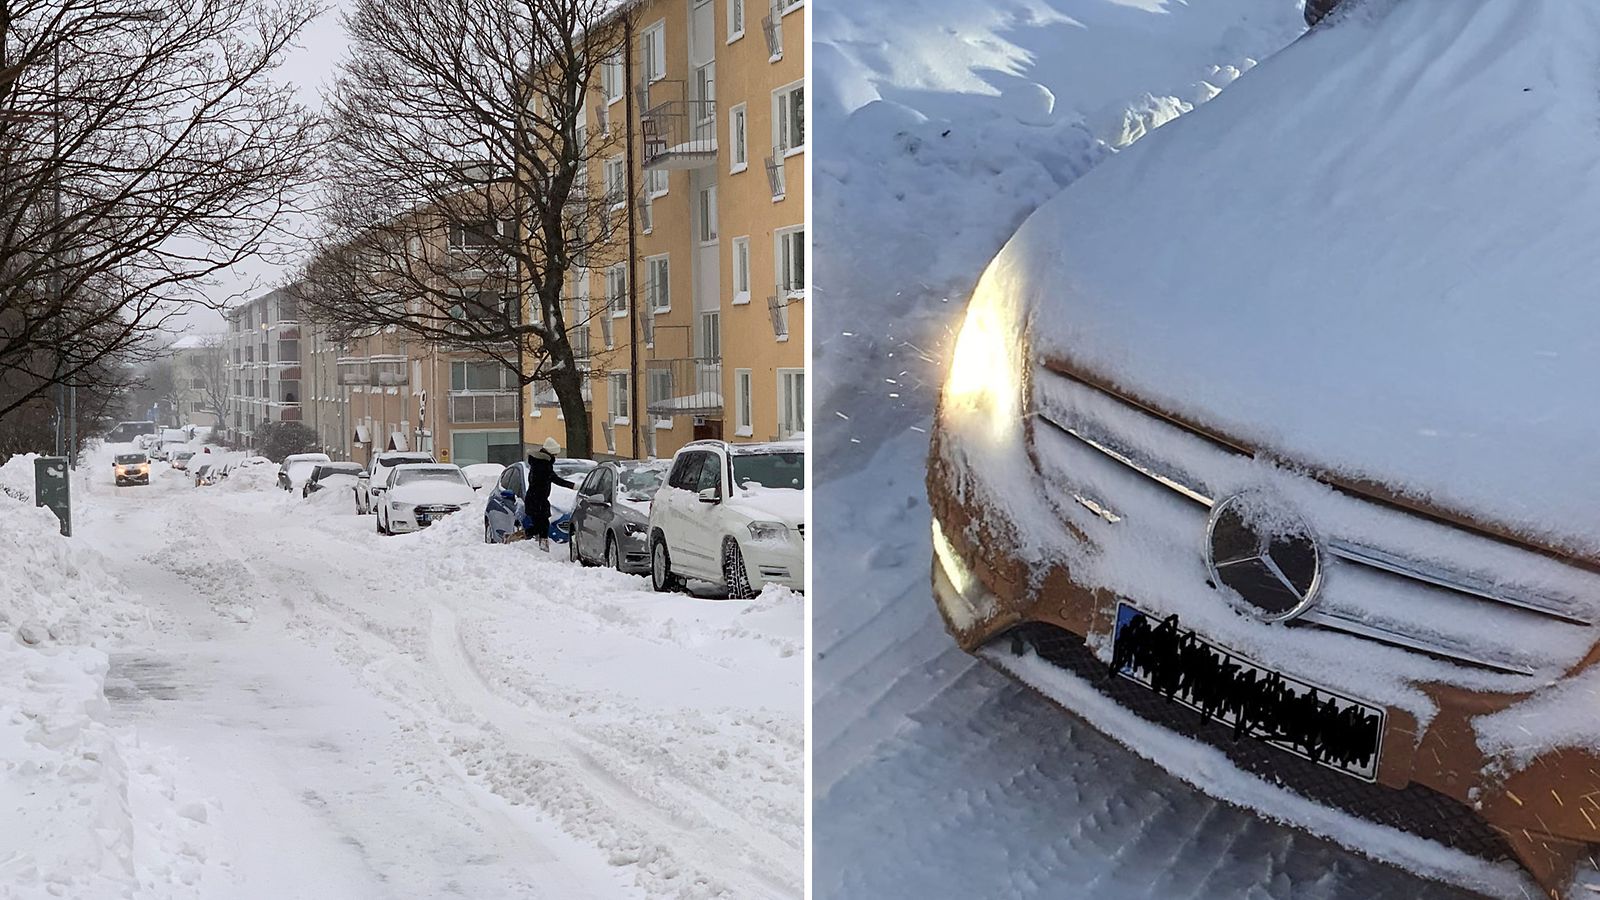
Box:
[0,441,803,900]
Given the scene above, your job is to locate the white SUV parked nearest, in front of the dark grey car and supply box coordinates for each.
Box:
[650,440,805,597]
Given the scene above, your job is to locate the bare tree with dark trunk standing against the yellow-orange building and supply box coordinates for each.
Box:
[296,0,634,456]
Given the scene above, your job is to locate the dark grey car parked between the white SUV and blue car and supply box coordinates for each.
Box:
[566,461,667,573]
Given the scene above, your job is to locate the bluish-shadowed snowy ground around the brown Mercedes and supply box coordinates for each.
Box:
[813,0,1484,900]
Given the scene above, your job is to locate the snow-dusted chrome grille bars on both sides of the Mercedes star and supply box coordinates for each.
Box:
[1032,368,1600,674]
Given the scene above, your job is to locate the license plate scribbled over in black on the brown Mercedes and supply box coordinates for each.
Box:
[1112,604,1384,781]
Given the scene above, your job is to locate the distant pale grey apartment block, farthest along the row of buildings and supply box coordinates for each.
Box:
[224,288,302,440]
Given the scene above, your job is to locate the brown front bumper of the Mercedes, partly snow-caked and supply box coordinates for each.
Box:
[928,416,1600,897]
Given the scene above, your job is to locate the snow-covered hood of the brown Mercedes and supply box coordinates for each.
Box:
[998,0,1600,552]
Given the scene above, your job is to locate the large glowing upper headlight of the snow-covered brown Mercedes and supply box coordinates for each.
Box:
[944,275,1022,437]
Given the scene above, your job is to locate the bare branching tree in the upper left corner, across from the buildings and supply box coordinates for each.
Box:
[0,0,320,421]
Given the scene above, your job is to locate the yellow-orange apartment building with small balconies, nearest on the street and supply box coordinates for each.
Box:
[522,0,806,458]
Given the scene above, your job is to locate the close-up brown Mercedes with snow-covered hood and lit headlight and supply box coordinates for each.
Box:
[928,3,1600,898]
